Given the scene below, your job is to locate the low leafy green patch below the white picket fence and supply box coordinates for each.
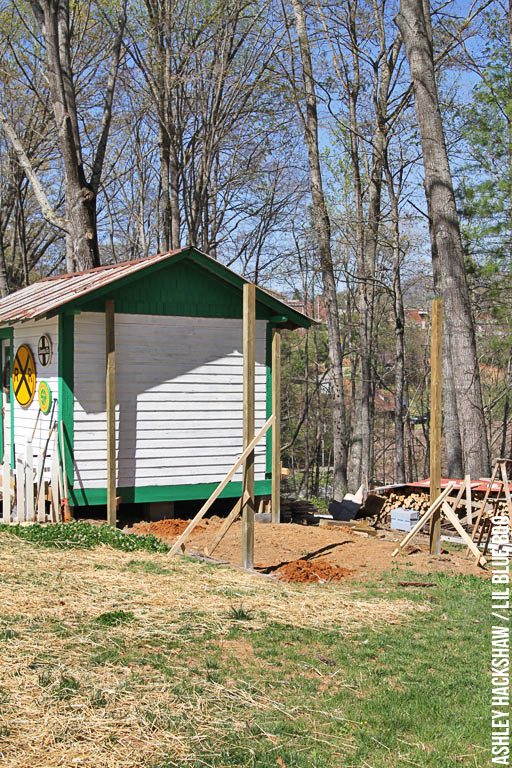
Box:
[0,522,169,552]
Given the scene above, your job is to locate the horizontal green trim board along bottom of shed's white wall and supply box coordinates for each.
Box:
[69,480,271,507]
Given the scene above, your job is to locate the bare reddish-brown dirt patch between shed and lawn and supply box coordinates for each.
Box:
[132,517,486,582]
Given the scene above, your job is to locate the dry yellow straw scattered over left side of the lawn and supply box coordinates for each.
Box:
[0,536,424,768]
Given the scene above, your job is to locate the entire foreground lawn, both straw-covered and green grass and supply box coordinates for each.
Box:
[0,529,490,768]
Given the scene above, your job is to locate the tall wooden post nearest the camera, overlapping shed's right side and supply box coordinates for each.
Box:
[242,284,256,570]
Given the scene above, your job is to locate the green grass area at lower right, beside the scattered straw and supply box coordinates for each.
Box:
[153,574,490,768]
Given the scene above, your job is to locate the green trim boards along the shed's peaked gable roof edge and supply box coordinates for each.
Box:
[55,247,312,328]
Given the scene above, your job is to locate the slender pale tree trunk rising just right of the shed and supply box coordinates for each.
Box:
[292,0,347,500]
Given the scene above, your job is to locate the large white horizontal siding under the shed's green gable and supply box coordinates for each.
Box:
[74,313,266,488]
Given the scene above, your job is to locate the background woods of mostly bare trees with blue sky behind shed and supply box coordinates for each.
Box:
[0,0,512,498]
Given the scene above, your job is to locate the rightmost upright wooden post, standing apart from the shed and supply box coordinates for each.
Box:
[430,298,443,555]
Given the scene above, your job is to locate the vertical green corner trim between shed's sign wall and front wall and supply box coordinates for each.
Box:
[58,313,75,490]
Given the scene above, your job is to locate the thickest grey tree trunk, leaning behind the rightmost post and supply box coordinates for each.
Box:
[397,0,489,477]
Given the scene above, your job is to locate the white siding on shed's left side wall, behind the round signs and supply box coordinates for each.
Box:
[14,318,59,472]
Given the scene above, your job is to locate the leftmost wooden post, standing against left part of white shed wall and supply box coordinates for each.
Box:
[105,299,117,528]
